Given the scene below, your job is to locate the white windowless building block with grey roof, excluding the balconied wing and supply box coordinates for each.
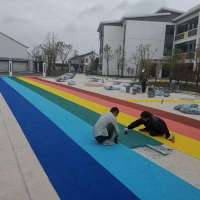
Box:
[98,8,183,77]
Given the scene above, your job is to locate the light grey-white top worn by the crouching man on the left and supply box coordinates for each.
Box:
[94,112,120,137]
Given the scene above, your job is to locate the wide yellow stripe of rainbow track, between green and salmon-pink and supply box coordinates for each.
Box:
[19,78,200,159]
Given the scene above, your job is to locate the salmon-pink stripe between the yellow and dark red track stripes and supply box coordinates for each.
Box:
[30,78,200,140]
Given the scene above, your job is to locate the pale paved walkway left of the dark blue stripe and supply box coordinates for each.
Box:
[0,95,59,200]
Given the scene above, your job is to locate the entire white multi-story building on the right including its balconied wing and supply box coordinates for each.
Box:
[98,5,200,78]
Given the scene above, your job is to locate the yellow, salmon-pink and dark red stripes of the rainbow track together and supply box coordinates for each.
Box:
[20,78,200,159]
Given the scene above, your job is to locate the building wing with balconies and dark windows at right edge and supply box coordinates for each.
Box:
[173,5,200,79]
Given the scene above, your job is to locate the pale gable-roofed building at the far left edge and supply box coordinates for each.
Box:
[0,32,33,73]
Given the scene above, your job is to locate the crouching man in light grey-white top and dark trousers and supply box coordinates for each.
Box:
[94,107,120,145]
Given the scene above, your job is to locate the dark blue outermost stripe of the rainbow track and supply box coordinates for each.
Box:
[0,79,138,200]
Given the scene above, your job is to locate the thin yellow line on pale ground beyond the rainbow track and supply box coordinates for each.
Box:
[128,99,200,104]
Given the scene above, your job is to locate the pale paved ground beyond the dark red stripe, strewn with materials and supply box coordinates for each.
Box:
[43,74,200,120]
